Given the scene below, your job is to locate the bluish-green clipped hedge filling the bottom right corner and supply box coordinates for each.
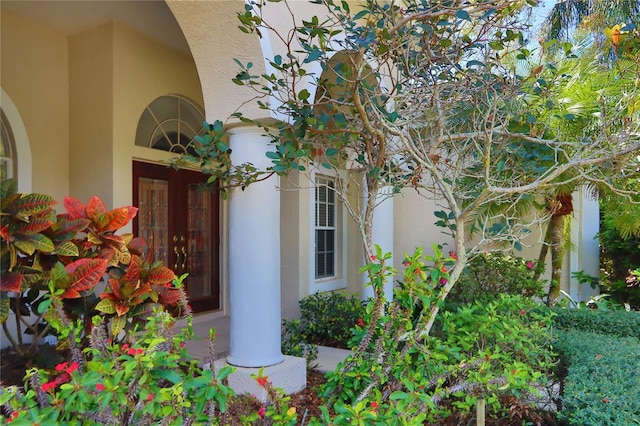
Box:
[555,330,640,426]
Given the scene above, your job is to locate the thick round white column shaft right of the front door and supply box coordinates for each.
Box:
[227,127,284,367]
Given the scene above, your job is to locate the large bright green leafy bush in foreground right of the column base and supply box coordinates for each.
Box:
[323,295,553,424]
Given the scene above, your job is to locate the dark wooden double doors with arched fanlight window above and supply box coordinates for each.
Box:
[133,95,221,312]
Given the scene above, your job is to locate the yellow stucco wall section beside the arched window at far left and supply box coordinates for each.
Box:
[0,12,69,201]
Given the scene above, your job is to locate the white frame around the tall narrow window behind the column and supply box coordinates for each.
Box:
[309,169,348,294]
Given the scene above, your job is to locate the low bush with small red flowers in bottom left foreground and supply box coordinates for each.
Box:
[0,312,242,425]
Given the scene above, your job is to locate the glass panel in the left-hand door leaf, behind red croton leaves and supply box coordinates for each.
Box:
[138,177,169,265]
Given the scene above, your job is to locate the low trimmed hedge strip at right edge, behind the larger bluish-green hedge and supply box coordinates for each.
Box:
[553,308,640,338]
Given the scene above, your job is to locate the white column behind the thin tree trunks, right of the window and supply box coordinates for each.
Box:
[362,186,393,300]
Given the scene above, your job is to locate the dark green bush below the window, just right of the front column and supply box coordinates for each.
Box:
[283,292,365,355]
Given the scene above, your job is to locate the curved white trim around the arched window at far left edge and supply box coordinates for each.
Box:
[0,88,32,193]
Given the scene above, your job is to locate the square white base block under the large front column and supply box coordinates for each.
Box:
[213,355,307,402]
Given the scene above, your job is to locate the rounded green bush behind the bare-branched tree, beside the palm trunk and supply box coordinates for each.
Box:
[447,252,544,304]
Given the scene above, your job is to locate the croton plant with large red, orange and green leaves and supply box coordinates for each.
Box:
[0,180,189,358]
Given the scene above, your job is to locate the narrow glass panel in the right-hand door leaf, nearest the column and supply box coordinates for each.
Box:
[187,184,212,298]
